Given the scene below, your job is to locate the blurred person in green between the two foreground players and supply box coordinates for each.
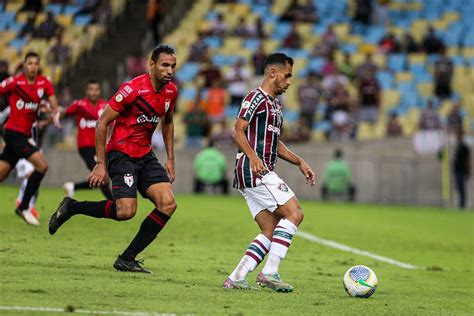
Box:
[193,141,229,194]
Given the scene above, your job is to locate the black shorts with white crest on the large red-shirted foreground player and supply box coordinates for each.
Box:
[107,151,170,199]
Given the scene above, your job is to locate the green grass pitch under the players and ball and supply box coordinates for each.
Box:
[0,185,474,315]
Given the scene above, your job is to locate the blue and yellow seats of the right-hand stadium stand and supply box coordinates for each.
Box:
[160,0,474,145]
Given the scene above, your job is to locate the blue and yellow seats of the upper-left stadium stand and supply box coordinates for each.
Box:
[0,0,127,84]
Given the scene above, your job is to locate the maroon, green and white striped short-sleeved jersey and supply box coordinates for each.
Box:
[234,88,283,189]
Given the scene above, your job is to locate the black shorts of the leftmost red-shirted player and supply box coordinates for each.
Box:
[0,129,38,168]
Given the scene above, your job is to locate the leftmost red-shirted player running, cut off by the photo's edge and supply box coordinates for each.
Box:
[0,52,60,225]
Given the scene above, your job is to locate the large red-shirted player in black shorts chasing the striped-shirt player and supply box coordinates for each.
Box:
[49,45,177,273]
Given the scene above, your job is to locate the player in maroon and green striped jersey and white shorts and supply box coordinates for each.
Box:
[223,53,315,292]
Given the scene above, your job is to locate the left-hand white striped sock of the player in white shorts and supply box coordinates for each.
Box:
[229,234,272,281]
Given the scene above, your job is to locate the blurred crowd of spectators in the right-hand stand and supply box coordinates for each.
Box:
[118,0,463,147]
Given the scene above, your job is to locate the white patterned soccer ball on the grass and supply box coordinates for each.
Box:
[343,266,377,298]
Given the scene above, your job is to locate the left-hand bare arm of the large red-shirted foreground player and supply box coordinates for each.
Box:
[88,106,120,188]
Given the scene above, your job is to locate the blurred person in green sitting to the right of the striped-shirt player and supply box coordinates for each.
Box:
[321,149,356,201]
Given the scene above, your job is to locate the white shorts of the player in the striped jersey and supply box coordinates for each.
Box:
[239,172,295,218]
